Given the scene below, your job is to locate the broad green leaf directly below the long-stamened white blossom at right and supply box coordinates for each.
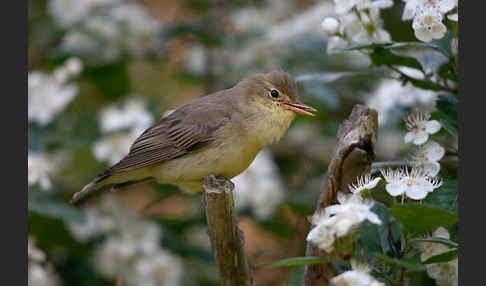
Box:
[391,203,458,235]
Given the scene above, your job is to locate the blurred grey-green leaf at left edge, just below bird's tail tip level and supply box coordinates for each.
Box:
[28,191,85,223]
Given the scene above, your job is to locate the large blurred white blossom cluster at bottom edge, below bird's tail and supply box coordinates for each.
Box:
[88,196,182,286]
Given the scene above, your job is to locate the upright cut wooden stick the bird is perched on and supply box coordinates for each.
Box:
[203,175,254,286]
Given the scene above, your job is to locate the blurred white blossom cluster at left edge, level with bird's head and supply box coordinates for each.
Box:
[27,58,82,126]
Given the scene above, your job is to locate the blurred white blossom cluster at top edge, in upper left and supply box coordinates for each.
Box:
[53,0,162,62]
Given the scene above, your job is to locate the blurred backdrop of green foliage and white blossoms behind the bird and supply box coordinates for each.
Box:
[28,0,450,286]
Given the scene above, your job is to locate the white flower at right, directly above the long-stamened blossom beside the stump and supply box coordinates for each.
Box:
[411,141,445,177]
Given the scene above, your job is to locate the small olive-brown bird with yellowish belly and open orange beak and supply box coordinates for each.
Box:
[71,70,317,203]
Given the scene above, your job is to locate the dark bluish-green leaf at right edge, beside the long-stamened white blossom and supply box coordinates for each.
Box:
[424,179,458,213]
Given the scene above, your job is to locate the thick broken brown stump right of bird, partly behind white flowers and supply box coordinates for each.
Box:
[304,104,378,286]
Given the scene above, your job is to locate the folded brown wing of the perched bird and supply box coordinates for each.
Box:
[100,110,230,177]
